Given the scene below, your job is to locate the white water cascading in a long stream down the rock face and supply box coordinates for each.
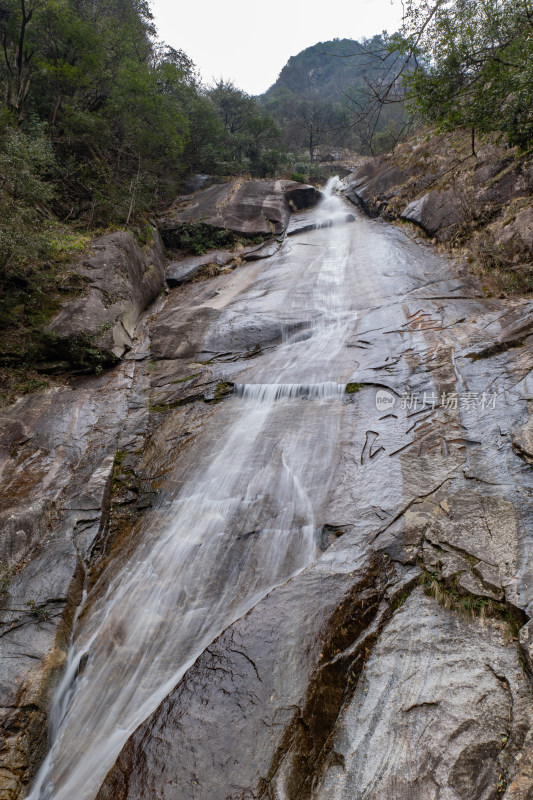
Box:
[29,178,354,800]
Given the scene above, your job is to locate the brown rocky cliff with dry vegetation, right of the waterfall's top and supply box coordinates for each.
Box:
[347,131,533,294]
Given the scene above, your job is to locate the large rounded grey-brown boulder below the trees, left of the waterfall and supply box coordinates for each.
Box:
[45,229,165,365]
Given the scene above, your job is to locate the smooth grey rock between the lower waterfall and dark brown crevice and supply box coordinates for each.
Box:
[98,564,390,800]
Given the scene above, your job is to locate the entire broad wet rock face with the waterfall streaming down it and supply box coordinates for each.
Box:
[0,181,533,800]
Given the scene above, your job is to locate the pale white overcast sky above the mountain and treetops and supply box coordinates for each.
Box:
[151,0,402,94]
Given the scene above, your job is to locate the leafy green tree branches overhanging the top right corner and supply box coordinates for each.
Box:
[391,0,533,152]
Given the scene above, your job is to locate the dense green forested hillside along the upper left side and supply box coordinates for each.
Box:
[0,0,282,400]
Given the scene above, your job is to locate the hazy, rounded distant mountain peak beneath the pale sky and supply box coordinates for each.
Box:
[259,35,405,161]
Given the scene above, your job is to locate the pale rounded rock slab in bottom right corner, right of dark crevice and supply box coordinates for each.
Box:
[311,589,532,800]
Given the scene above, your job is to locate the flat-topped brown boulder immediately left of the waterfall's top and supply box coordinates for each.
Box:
[159,179,321,241]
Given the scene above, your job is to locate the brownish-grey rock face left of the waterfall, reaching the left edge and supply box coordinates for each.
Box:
[0,316,157,799]
